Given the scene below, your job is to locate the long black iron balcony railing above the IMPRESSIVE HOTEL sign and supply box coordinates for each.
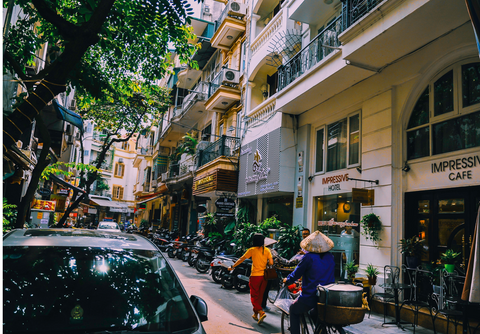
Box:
[278,16,344,90]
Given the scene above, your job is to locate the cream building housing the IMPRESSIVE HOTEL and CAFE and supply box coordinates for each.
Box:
[239,0,480,276]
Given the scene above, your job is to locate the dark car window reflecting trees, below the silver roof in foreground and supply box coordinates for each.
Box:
[3,246,199,333]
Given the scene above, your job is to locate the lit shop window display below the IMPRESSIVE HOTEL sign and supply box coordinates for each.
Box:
[316,193,361,278]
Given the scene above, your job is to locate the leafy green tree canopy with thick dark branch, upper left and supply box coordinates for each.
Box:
[3,0,195,149]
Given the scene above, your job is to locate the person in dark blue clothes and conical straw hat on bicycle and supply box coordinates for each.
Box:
[283,231,335,334]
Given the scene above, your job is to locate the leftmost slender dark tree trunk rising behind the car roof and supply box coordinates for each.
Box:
[15,117,52,228]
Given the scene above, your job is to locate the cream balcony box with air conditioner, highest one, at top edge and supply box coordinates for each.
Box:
[210,1,247,50]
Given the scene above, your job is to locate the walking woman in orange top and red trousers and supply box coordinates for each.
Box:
[228,233,273,324]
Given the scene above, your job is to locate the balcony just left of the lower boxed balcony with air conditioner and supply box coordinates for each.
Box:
[172,81,209,126]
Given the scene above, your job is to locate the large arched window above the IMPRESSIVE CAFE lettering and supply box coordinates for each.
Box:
[407,62,480,160]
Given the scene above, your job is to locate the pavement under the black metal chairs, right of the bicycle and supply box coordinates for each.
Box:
[344,313,433,334]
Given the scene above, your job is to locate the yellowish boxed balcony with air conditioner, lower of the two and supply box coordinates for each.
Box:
[205,68,241,112]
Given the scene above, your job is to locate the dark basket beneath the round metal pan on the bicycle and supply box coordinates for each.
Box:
[317,303,367,326]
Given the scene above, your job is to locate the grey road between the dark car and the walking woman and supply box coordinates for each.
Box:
[167,257,281,334]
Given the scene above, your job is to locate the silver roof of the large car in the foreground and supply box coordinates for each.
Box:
[3,228,158,251]
